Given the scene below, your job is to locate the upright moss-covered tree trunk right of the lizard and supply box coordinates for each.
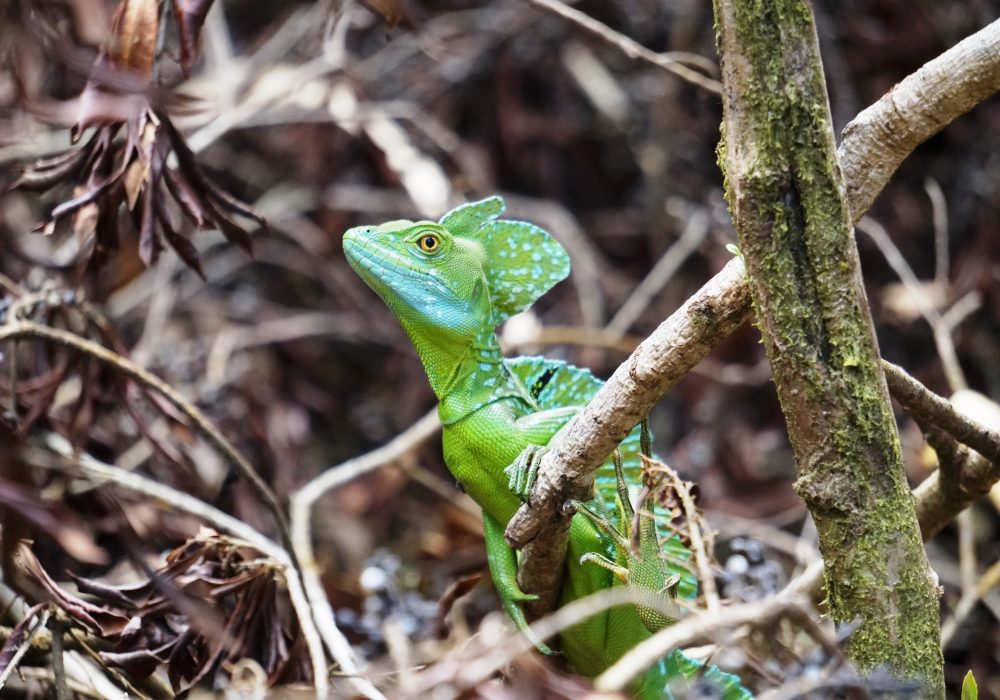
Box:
[715,0,944,697]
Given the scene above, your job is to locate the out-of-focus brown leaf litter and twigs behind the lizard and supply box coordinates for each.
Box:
[0,0,1000,697]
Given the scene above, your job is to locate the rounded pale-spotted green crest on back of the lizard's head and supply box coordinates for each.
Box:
[438,197,570,325]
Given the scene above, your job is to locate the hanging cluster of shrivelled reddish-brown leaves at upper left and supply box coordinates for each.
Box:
[12,0,266,276]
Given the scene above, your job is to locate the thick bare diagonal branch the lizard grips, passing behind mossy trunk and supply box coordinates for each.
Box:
[507,15,1000,656]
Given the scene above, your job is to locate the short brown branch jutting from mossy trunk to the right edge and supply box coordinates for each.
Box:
[882,360,1000,462]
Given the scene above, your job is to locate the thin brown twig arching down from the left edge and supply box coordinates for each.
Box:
[0,321,292,564]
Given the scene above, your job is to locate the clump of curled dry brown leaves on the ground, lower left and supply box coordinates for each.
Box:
[12,530,311,693]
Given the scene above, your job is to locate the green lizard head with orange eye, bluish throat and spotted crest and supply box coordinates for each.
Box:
[344,197,569,340]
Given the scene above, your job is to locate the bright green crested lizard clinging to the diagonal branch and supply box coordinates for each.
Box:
[344,197,750,699]
